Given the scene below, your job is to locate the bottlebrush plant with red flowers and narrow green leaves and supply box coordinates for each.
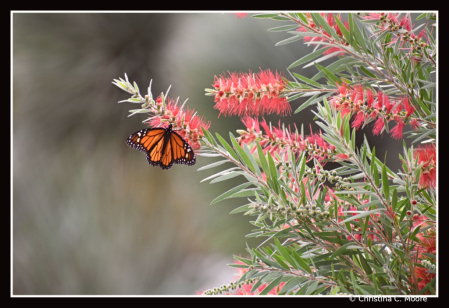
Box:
[114,13,438,295]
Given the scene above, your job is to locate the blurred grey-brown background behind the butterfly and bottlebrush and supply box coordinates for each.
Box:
[13,13,410,295]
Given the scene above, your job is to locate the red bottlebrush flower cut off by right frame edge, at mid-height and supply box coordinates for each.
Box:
[413,144,437,188]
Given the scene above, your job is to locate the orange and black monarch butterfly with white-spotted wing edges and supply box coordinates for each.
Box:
[126,124,196,170]
